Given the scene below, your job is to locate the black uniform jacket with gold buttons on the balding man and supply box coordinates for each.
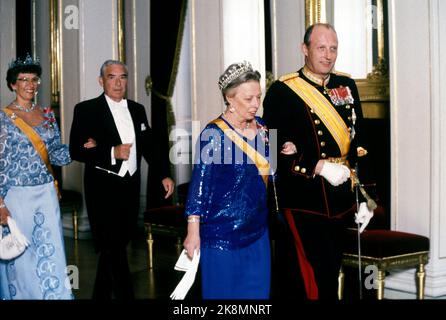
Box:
[263,69,363,217]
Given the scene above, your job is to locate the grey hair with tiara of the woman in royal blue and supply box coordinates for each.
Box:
[218,61,261,105]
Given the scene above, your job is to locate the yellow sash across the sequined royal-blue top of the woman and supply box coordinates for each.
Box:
[211,119,270,186]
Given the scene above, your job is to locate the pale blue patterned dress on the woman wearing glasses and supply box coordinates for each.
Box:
[0,109,73,300]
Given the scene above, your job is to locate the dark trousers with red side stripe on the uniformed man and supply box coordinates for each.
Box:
[274,210,346,300]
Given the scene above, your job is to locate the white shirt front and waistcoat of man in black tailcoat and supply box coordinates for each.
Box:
[105,95,137,177]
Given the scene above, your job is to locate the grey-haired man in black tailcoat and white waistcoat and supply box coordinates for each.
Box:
[70,60,174,299]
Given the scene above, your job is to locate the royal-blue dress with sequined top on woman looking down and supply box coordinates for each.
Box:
[186,117,270,299]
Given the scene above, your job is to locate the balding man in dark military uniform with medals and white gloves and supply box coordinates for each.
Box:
[263,23,373,299]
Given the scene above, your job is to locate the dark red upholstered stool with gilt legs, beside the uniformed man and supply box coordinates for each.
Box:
[338,207,429,300]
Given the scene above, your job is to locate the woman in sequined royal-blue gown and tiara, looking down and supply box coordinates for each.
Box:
[184,62,271,299]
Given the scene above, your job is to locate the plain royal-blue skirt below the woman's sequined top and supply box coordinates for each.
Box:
[200,231,271,299]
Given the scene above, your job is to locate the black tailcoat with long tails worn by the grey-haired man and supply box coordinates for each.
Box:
[70,94,169,249]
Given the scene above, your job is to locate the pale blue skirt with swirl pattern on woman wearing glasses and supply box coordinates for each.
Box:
[0,183,73,300]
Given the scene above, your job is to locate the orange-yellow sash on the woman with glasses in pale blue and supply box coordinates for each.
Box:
[3,108,61,199]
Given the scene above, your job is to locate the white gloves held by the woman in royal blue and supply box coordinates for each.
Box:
[170,249,200,300]
